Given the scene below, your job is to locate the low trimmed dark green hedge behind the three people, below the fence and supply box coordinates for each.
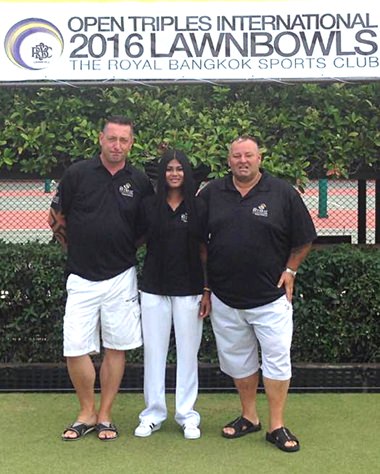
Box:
[0,242,380,363]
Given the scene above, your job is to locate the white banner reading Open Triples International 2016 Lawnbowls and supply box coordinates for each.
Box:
[0,0,380,83]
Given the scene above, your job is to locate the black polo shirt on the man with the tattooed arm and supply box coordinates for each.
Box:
[52,157,153,281]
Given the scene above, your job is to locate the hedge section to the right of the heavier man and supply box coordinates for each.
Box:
[293,245,380,363]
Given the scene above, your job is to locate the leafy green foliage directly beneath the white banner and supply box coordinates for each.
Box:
[0,83,380,184]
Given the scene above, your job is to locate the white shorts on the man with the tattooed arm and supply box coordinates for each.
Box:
[63,267,142,357]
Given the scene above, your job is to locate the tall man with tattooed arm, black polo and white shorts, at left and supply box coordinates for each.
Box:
[49,116,153,441]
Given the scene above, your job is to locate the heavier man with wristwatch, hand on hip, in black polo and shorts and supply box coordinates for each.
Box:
[200,136,316,452]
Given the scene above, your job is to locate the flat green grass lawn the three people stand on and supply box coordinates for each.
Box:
[0,393,380,474]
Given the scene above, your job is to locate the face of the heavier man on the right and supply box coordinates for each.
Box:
[228,140,261,182]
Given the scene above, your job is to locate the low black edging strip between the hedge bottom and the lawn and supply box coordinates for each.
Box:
[0,363,380,393]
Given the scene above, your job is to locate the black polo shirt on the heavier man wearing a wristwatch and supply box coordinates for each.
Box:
[200,171,316,309]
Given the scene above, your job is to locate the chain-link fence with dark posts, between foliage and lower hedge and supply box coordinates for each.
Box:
[0,179,380,244]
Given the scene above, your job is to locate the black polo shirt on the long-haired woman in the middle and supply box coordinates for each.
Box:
[140,196,203,296]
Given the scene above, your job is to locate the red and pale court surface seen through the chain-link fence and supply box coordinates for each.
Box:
[0,180,375,244]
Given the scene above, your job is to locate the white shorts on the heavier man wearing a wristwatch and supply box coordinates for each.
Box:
[211,294,293,380]
